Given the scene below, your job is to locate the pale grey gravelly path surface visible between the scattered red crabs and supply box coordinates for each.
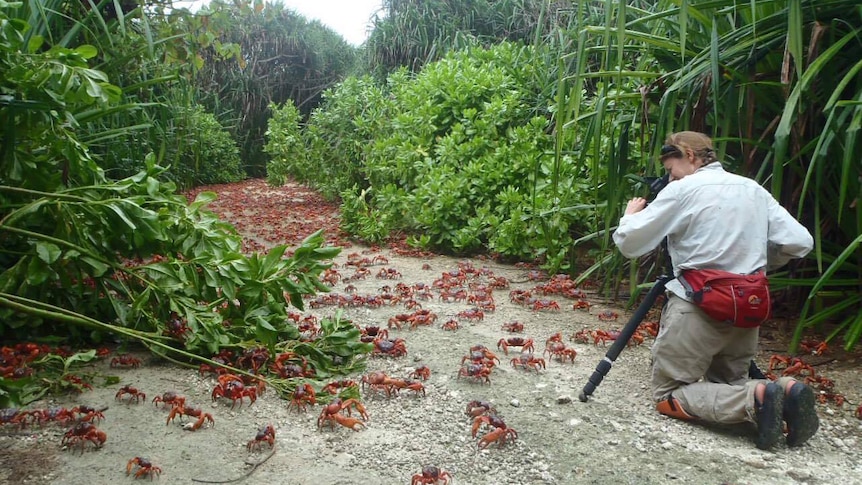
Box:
[0,182,862,485]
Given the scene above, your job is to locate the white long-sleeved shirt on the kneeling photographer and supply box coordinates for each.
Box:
[613,162,814,298]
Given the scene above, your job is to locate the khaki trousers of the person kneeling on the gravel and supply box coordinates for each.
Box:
[652,294,769,424]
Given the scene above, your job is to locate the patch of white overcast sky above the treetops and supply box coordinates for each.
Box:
[174,0,383,46]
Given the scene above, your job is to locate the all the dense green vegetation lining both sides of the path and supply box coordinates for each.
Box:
[0,0,862,404]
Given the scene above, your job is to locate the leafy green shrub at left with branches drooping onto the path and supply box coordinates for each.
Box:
[0,11,371,406]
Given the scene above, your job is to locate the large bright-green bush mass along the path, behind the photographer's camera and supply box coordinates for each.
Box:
[286,43,594,269]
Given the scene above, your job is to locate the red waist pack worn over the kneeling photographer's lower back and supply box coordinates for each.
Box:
[677,269,772,328]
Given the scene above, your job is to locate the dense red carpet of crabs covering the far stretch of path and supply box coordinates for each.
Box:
[184,179,351,252]
